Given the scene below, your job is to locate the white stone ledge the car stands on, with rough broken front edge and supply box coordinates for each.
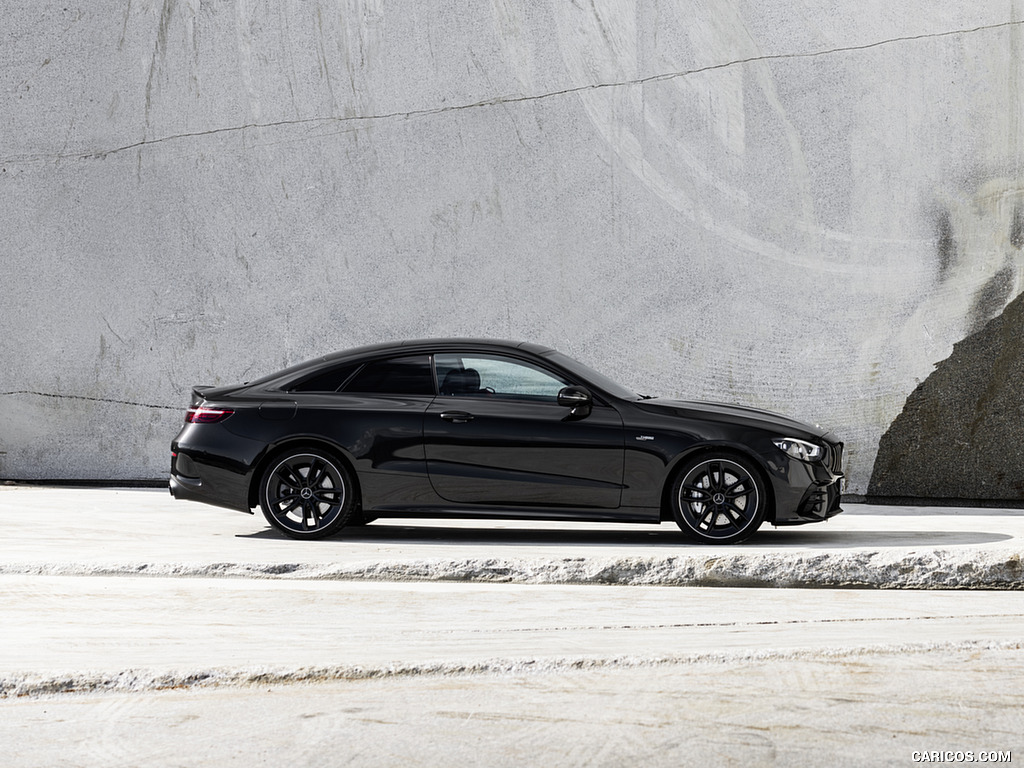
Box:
[0,485,1024,589]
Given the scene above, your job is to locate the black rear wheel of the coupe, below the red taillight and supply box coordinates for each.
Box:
[259,449,355,539]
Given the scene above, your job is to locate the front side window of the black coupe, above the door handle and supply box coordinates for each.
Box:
[434,354,567,402]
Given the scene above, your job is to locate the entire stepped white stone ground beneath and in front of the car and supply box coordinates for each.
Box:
[0,486,1024,768]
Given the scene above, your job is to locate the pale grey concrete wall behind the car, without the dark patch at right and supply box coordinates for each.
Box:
[0,0,1024,497]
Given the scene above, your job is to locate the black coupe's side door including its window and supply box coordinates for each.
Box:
[423,352,624,509]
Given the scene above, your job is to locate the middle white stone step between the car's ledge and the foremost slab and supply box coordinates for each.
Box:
[0,575,1024,696]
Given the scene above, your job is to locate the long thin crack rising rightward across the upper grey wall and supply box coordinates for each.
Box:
[6,20,1024,163]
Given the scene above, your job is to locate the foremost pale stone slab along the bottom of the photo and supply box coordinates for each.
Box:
[0,648,1024,768]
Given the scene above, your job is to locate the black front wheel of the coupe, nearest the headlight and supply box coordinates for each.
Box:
[670,453,768,544]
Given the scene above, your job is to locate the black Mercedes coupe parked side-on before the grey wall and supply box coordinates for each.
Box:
[170,339,843,544]
